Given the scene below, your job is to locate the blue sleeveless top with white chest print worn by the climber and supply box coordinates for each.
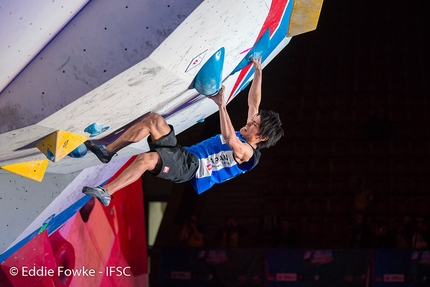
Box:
[184,132,261,194]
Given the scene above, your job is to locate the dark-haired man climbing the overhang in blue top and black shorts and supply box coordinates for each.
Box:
[82,58,284,206]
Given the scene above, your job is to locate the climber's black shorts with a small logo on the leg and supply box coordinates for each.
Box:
[148,125,199,183]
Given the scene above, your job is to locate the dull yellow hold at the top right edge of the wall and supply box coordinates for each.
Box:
[287,0,323,37]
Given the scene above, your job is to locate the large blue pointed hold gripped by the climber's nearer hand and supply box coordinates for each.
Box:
[192,47,225,96]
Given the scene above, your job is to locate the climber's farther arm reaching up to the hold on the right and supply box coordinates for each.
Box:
[247,57,263,122]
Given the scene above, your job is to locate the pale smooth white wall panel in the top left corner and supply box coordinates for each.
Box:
[0,0,89,92]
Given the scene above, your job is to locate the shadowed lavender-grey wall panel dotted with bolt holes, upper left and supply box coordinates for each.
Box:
[0,0,202,133]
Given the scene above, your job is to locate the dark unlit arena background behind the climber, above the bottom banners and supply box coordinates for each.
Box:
[147,0,430,248]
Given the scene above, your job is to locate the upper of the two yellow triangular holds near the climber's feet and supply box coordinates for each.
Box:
[36,130,87,162]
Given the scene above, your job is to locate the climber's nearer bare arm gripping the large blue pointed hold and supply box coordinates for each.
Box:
[209,86,254,164]
